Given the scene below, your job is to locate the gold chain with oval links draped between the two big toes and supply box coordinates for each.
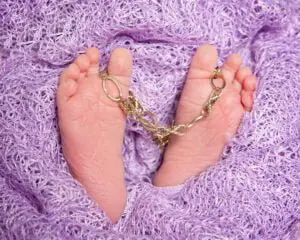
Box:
[100,67,226,147]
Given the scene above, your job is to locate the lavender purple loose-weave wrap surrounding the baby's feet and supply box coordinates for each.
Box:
[0,0,300,240]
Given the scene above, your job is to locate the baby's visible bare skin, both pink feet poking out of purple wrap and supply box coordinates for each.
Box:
[57,45,256,223]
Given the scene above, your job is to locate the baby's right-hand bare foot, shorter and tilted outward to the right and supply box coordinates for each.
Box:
[153,45,256,186]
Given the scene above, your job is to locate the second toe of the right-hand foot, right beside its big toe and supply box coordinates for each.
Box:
[222,54,242,84]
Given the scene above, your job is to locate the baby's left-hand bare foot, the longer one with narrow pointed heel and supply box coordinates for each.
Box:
[57,48,132,222]
